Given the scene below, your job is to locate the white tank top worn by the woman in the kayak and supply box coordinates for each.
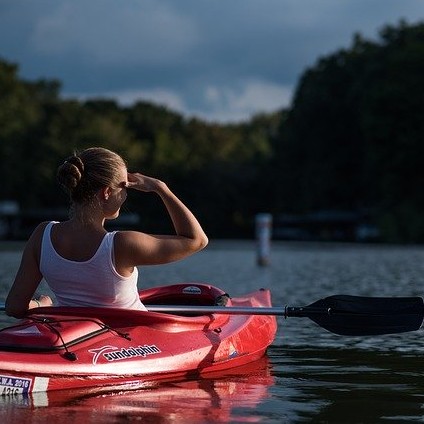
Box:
[40,222,146,310]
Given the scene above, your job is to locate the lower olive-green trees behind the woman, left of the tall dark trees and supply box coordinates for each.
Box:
[0,61,278,237]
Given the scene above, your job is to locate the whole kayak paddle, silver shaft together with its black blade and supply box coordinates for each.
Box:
[0,295,424,336]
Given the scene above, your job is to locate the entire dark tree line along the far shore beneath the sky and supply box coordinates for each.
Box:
[0,21,424,243]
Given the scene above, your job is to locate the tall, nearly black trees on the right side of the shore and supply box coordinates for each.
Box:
[280,22,424,242]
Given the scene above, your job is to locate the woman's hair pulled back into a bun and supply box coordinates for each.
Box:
[57,147,126,203]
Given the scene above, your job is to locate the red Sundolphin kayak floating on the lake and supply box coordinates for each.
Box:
[0,283,277,395]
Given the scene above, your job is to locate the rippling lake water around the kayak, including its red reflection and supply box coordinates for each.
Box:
[0,241,424,424]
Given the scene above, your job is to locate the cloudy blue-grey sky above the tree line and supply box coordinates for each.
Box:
[0,0,424,122]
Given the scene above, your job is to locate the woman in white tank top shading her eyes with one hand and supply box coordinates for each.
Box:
[6,147,208,318]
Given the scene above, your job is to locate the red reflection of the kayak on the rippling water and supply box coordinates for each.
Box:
[0,357,274,423]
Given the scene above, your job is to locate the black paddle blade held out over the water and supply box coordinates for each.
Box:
[288,295,424,336]
